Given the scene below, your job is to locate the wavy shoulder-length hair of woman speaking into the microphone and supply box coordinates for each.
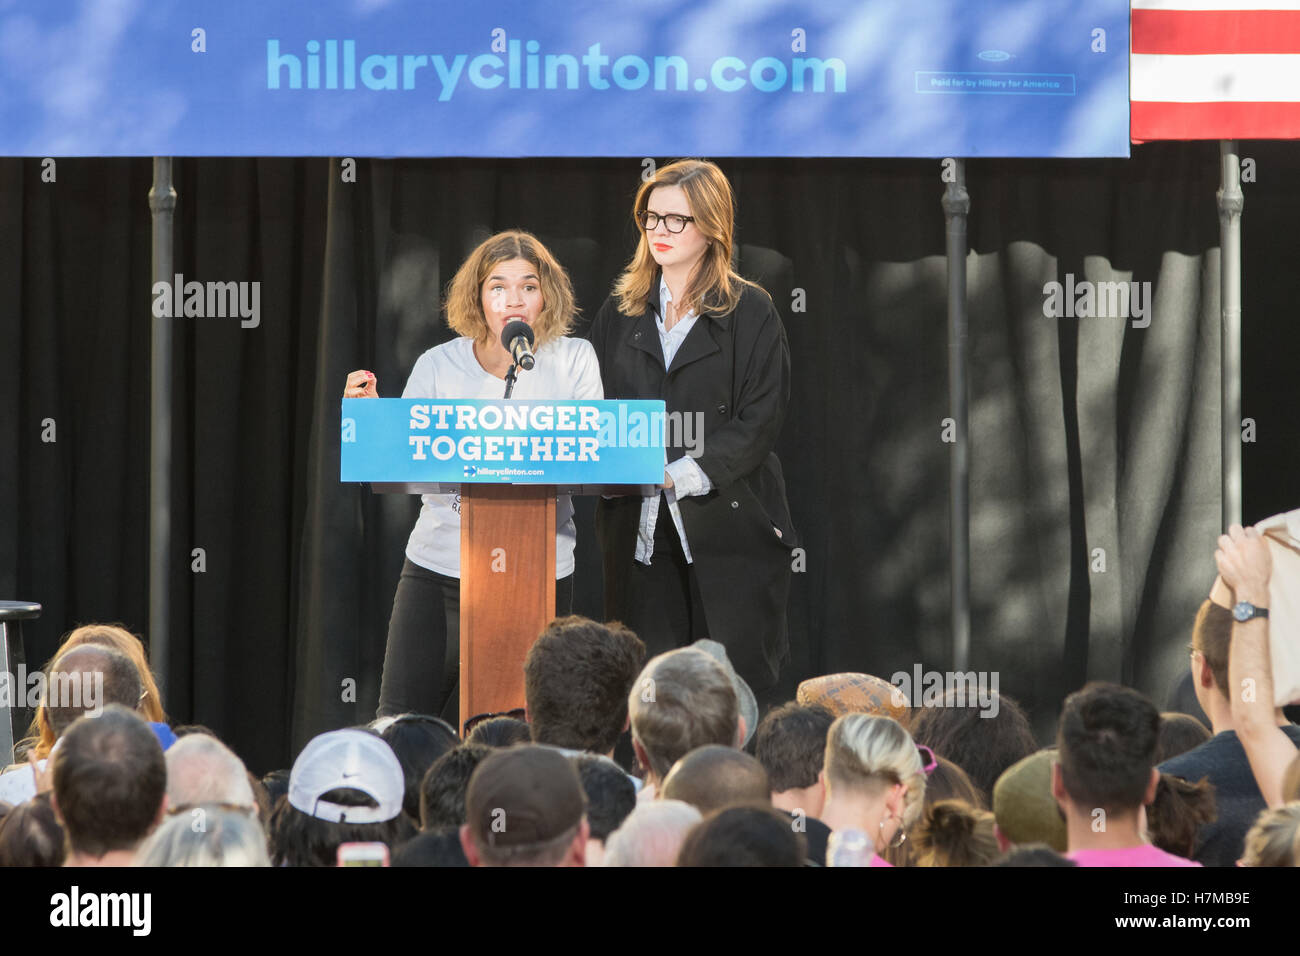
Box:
[443,229,577,350]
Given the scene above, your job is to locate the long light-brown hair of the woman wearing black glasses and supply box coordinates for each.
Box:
[614,160,754,315]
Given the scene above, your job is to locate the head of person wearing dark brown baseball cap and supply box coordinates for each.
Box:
[460,744,589,866]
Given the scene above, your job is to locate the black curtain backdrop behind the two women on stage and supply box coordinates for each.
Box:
[0,149,1300,773]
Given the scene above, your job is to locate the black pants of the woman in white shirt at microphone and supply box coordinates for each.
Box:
[377,558,573,727]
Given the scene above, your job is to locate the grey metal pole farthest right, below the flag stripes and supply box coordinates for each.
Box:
[1218,139,1244,532]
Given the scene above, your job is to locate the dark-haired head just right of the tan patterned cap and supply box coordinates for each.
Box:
[909,688,1039,806]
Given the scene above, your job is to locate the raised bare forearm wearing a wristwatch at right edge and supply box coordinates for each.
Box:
[1214,524,1300,814]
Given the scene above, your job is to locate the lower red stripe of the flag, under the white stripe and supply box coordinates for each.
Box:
[1128,100,1300,143]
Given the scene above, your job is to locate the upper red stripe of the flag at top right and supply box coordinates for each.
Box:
[1131,9,1300,53]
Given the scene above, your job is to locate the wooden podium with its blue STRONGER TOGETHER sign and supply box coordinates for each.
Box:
[339,398,664,730]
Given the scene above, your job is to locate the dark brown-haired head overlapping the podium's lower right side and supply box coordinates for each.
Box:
[524,615,646,757]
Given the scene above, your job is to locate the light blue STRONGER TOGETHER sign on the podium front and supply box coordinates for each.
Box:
[339,398,665,485]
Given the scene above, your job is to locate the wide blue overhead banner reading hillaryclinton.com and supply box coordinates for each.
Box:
[0,0,1128,157]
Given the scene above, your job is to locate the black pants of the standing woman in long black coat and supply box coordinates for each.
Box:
[623,494,709,661]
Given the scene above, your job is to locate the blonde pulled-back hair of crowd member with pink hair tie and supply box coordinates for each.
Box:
[824,714,926,830]
